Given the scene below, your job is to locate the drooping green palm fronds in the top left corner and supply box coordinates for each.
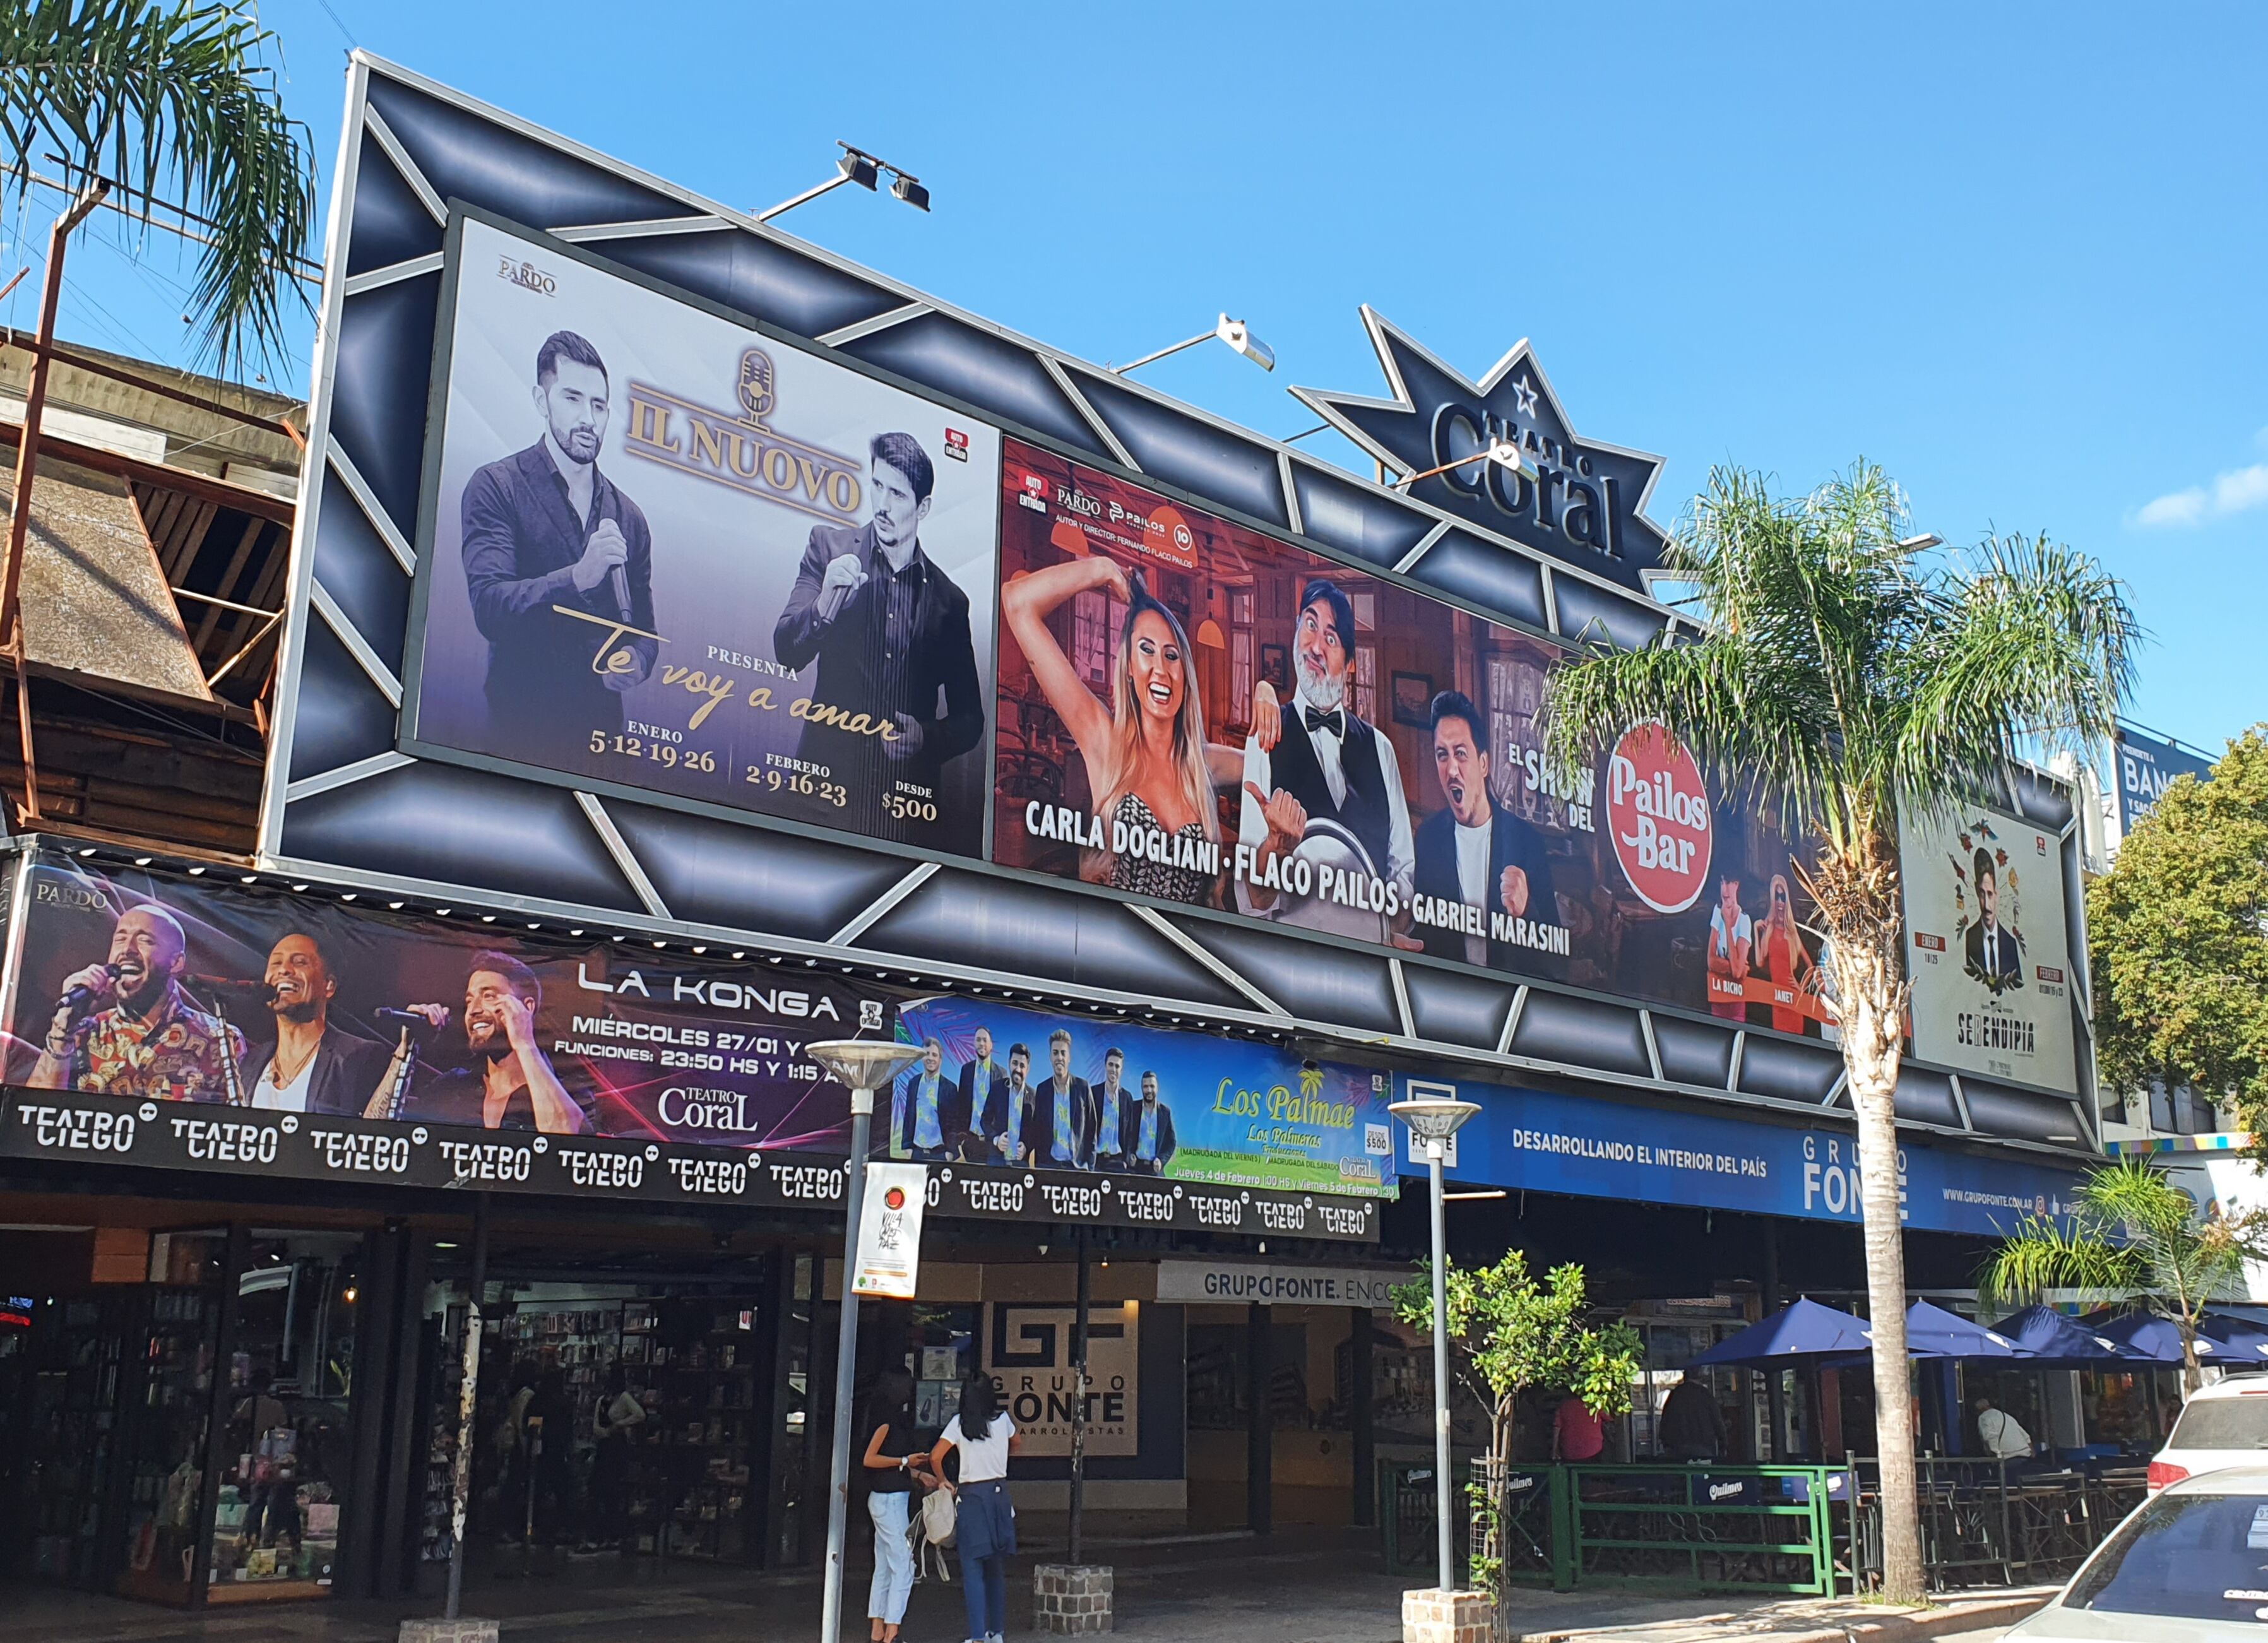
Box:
[0,0,315,372]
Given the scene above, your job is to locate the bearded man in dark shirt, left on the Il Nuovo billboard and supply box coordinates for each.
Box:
[463,331,658,769]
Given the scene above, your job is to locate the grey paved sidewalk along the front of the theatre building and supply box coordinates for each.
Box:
[0,1529,2059,1643]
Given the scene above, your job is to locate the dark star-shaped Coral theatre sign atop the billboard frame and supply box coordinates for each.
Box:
[1293,304,1667,590]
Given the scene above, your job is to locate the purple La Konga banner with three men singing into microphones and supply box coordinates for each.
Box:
[7,855,891,1158]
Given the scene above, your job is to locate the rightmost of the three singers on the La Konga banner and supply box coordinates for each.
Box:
[363,953,590,1135]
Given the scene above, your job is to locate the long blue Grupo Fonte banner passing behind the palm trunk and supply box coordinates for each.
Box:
[1397,1078,2080,1235]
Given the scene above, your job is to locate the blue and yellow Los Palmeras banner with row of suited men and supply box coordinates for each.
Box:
[876,996,1397,1198]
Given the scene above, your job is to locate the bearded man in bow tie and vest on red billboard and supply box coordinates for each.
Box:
[1236,576,1415,923]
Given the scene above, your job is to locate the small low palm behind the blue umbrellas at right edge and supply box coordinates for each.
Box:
[1978,1158,2268,1396]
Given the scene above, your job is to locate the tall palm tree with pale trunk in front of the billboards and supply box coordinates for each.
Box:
[1549,463,2137,1600]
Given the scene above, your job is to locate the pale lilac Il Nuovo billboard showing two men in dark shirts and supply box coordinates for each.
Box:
[401,216,998,855]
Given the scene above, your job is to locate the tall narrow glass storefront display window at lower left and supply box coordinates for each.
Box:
[211,1232,360,1602]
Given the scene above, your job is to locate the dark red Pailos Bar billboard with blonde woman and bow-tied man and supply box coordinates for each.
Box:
[994,438,1835,1037]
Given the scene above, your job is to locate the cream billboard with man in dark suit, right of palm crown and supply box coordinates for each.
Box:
[1898,808,2077,1091]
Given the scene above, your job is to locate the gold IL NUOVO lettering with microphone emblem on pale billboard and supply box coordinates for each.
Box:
[624,347,867,525]
